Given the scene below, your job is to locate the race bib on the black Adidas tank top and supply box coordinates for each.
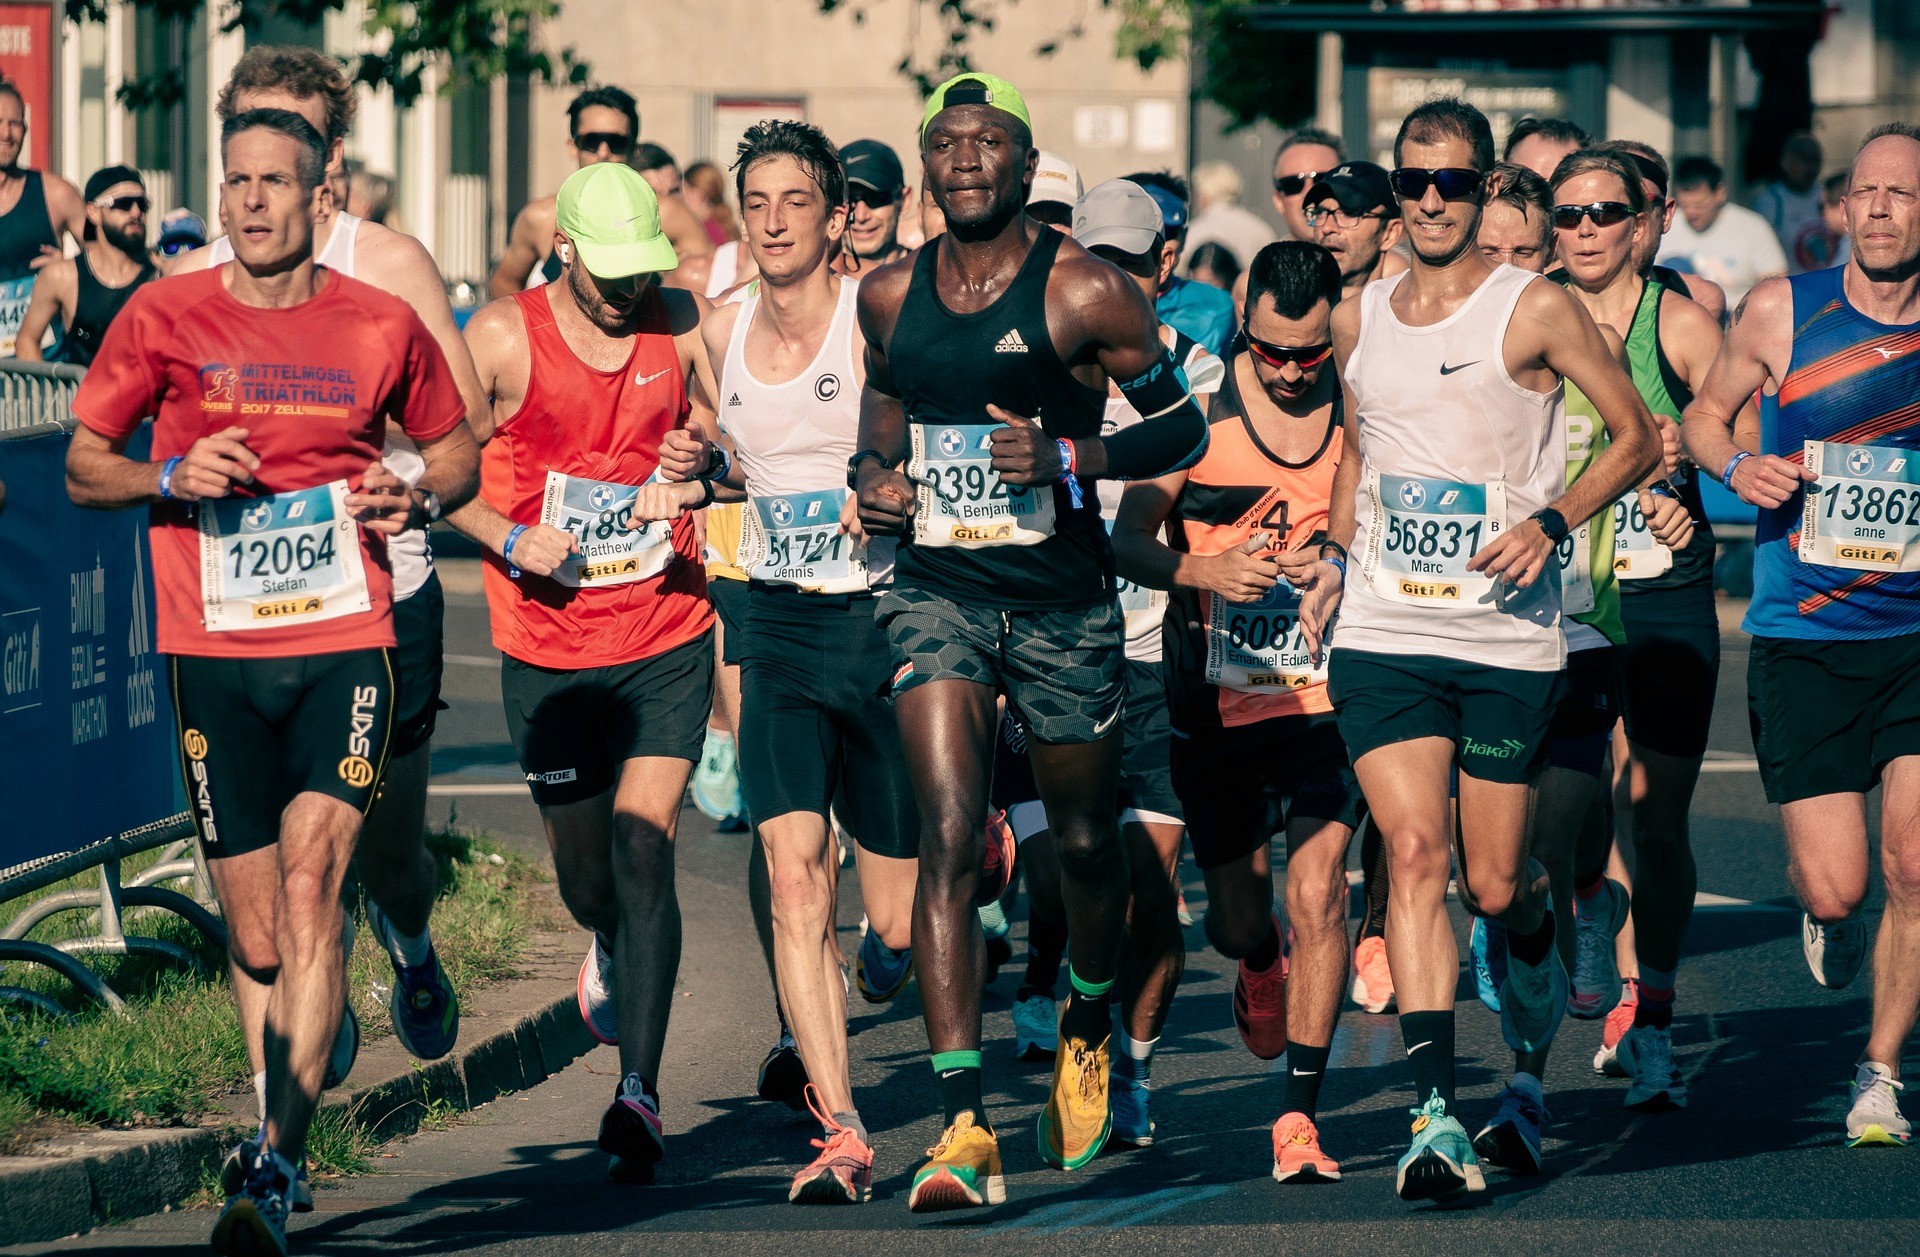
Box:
[906,422,1054,549]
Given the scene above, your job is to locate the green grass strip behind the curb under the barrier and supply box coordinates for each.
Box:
[0,825,553,1173]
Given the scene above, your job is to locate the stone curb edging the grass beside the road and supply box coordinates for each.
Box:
[0,959,597,1244]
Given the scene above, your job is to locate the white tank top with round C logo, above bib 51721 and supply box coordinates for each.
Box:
[720,278,895,587]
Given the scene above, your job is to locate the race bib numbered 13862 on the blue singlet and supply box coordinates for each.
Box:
[1799,441,1920,572]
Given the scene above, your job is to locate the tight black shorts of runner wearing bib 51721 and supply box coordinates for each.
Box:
[737,583,920,860]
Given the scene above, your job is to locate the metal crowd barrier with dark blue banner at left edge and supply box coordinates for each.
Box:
[0,361,227,1013]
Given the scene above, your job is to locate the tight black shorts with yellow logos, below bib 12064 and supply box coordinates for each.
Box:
[167,649,394,860]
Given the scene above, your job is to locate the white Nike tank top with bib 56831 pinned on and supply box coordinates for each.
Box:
[1331,267,1567,672]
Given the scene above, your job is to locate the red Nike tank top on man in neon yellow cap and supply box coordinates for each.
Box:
[480,286,714,672]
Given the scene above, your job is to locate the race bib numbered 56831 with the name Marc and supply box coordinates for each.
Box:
[1365,472,1507,606]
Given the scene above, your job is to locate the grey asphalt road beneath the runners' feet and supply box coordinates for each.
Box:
[21,575,1920,1257]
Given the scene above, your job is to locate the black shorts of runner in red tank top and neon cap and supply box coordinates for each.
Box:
[499,631,714,808]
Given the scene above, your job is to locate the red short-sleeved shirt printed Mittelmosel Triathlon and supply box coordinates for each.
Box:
[73,263,467,658]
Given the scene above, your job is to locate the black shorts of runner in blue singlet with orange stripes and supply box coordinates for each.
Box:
[1747,633,1920,804]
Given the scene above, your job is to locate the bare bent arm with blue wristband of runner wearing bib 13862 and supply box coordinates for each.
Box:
[1682,278,1814,507]
